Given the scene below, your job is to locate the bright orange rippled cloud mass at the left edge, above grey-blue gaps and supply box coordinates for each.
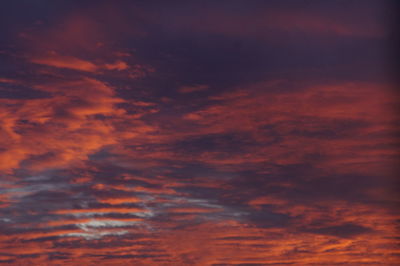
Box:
[0,75,158,171]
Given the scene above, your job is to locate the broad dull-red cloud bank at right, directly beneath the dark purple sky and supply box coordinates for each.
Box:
[180,83,397,175]
